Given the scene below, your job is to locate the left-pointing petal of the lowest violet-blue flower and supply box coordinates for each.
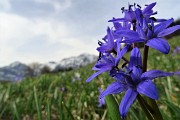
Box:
[99,82,127,99]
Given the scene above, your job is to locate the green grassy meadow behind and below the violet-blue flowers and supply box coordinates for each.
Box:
[0,37,180,120]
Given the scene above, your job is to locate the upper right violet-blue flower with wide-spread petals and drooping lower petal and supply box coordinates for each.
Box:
[116,19,180,54]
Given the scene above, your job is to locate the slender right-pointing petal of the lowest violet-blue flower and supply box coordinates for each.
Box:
[141,70,174,80]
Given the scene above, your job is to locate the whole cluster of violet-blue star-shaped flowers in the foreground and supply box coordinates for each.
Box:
[86,3,180,118]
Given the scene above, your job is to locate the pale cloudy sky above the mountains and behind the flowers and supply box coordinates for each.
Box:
[0,0,180,66]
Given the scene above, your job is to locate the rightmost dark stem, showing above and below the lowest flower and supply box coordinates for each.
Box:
[143,45,163,120]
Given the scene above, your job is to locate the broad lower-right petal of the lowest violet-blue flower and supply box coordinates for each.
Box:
[137,80,158,100]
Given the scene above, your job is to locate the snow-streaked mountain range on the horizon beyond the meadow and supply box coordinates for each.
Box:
[0,54,97,82]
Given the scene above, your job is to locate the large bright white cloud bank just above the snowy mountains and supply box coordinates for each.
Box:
[0,12,95,66]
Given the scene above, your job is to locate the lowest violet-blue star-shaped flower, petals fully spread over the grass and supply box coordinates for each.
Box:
[100,48,174,118]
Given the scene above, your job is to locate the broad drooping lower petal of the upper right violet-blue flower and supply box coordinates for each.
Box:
[146,38,170,54]
